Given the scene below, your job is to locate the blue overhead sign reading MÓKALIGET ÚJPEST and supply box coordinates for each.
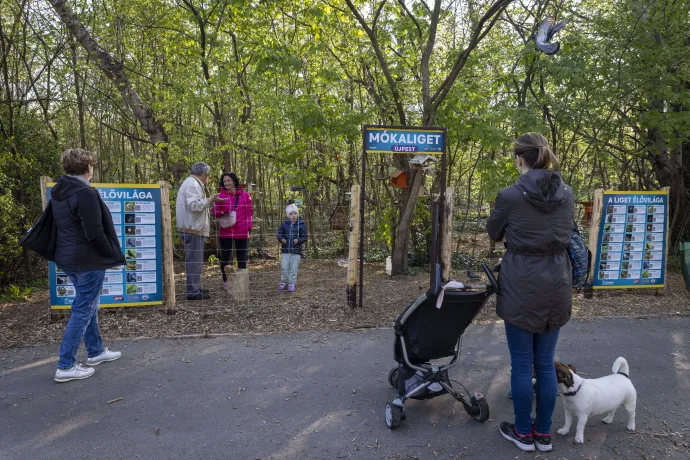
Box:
[363,126,446,155]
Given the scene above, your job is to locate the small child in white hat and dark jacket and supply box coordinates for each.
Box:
[276,204,307,292]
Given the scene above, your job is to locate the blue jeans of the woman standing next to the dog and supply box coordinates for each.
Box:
[505,323,559,435]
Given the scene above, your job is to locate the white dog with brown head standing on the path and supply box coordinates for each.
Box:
[555,357,637,444]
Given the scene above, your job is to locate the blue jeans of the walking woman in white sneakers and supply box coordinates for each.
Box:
[58,270,105,369]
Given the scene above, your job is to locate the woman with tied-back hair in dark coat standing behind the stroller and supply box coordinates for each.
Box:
[486,133,574,451]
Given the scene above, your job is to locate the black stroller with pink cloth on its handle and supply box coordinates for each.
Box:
[386,264,498,429]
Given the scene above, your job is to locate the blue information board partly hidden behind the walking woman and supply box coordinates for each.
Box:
[46,183,163,310]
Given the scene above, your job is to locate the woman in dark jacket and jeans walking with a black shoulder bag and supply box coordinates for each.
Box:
[51,149,125,382]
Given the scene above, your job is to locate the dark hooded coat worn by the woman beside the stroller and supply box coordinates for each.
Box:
[486,169,575,333]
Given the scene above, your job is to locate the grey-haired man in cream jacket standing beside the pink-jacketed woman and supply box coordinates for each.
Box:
[176,162,225,300]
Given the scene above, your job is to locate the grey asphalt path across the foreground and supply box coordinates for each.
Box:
[0,318,690,460]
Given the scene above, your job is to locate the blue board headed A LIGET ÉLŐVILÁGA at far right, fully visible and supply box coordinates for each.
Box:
[594,191,668,289]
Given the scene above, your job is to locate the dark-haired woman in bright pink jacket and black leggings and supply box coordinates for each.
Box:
[213,172,254,289]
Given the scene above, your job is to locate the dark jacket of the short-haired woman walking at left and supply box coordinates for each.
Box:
[50,176,125,272]
